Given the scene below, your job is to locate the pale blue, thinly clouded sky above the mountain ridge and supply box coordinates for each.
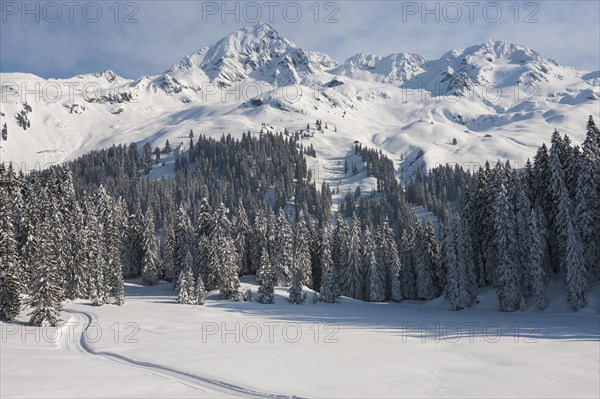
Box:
[0,0,600,78]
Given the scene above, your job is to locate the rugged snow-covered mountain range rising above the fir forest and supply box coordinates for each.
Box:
[0,24,600,177]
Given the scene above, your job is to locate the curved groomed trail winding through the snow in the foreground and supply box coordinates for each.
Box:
[61,309,299,399]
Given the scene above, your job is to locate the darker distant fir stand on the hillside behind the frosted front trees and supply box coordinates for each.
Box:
[70,133,331,234]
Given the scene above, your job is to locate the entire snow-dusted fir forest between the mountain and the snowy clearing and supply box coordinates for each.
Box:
[0,116,600,326]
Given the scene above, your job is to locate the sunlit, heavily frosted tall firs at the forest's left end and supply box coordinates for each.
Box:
[0,164,127,326]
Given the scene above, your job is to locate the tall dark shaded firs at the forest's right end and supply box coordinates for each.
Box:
[441,117,600,311]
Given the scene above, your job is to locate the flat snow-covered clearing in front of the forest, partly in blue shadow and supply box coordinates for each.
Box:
[0,277,600,398]
